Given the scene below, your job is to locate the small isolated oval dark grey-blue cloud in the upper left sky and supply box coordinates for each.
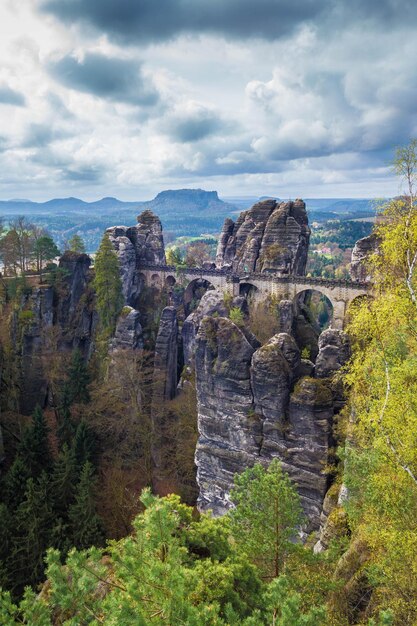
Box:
[49,53,159,106]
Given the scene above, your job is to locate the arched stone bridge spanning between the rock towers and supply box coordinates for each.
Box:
[139,265,372,329]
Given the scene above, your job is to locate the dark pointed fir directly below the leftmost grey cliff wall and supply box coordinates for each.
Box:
[18,405,52,477]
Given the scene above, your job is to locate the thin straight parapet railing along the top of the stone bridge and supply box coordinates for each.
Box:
[139,263,372,290]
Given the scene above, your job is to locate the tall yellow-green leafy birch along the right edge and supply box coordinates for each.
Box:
[345,142,417,625]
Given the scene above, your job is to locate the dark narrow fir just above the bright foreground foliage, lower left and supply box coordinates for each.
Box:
[68,461,104,550]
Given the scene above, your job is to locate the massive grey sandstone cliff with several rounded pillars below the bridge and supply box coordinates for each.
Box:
[195,308,349,529]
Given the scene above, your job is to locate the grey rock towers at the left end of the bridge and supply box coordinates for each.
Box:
[106,210,166,306]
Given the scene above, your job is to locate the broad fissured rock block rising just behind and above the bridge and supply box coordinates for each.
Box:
[216,200,310,275]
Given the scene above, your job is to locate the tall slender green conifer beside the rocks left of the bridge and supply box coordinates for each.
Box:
[93,234,123,335]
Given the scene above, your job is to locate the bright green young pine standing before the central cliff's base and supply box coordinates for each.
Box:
[230,459,302,578]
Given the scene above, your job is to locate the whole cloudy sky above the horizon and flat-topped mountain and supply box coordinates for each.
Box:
[0,0,417,200]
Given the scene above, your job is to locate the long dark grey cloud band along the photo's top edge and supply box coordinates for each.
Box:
[40,0,416,44]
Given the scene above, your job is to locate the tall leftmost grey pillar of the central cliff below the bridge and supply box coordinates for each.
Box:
[195,317,256,515]
